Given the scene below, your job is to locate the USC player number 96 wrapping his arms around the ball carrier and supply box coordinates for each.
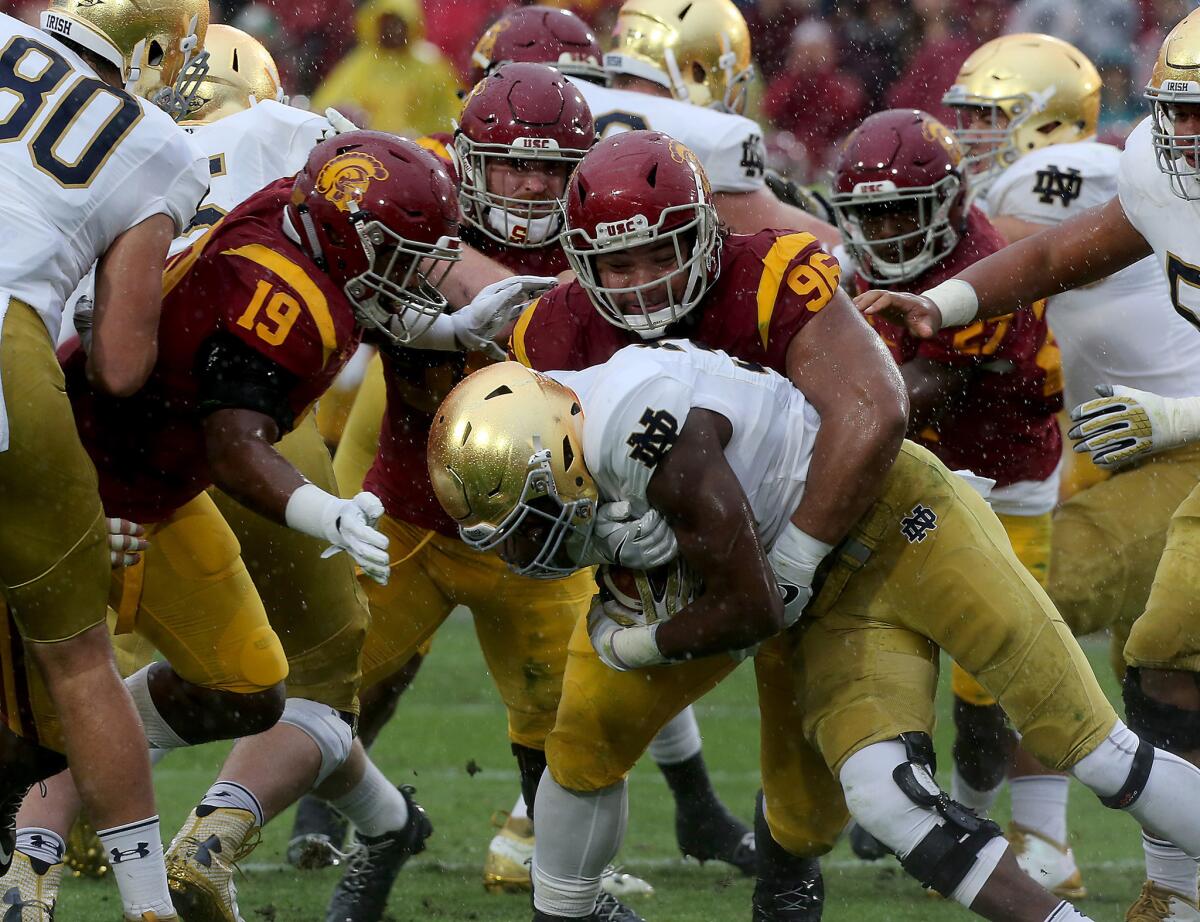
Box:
[510,131,907,922]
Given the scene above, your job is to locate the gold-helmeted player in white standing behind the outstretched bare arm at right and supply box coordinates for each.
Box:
[946,35,1200,892]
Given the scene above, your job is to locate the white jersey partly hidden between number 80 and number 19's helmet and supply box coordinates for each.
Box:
[170,100,330,255]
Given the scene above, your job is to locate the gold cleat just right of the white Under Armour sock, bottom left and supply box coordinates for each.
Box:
[167,804,260,922]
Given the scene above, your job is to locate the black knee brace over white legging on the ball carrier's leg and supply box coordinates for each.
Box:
[841,734,1004,906]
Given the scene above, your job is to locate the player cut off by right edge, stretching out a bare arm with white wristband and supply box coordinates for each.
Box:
[858,13,1200,918]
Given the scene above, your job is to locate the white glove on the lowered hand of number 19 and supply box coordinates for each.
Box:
[284,484,390,586]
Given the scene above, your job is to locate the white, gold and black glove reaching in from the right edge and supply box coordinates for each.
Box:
[1067,384,1200,471]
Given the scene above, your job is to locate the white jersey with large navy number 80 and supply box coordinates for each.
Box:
[0,14,209,339]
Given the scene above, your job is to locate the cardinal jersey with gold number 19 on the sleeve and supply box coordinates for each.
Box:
[64,179,361,523]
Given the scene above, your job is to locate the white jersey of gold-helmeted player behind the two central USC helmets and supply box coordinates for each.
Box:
[572,79,767,192]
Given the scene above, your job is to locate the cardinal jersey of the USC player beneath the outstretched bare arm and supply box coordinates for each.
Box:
[857,209,1062,504]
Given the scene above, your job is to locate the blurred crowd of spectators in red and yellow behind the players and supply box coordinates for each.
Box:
[7,0,1196,181]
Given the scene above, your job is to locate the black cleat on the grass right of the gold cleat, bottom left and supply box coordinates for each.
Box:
[325,784,433,922]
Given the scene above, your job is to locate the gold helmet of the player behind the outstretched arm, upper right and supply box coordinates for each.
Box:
[942,32,1100,197]
